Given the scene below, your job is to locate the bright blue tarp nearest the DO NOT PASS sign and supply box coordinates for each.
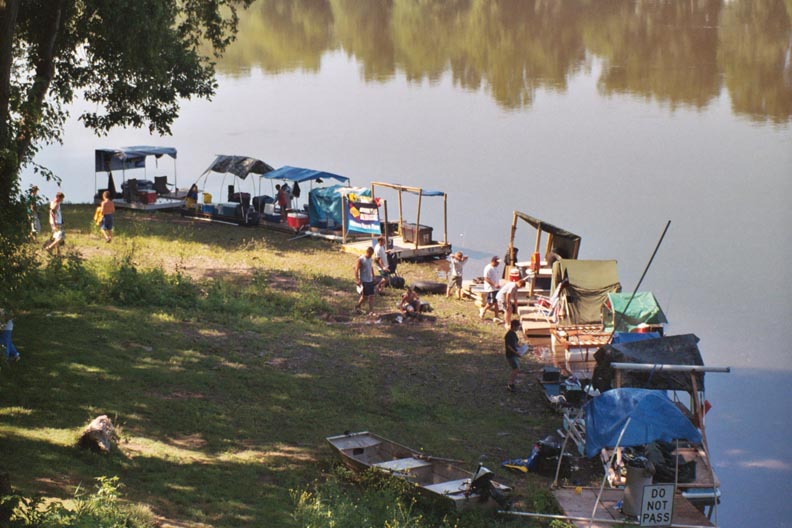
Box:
[584,389,701,458]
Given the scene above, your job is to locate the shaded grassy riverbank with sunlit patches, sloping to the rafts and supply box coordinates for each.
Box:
[0,206,558,527]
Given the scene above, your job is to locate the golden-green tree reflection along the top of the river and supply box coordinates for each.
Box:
[218,0,792,123]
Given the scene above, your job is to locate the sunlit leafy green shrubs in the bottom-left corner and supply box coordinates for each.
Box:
[2,477,156,528]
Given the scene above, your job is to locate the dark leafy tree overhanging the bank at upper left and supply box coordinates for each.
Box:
[0,0,251,296]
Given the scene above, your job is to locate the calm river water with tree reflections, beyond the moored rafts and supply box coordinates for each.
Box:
[24,0,792,527]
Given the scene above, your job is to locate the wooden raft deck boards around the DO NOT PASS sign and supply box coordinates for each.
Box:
[553,488,715,528]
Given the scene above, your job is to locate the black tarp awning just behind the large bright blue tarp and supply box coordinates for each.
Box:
[592,334,704,392]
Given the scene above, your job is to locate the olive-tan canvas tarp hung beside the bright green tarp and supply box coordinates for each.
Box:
[551,259,621,325]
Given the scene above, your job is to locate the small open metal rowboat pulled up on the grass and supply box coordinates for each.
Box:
[327,432,511,510]
